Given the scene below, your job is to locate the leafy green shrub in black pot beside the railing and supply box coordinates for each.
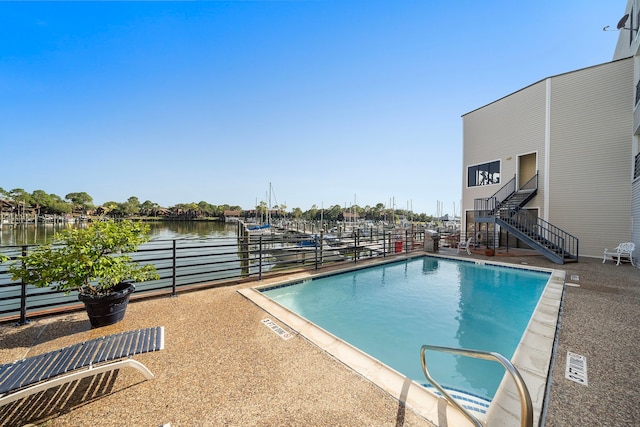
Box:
[8,221,159,327]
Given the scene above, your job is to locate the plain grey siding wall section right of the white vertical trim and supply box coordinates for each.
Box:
[548,59,633,256]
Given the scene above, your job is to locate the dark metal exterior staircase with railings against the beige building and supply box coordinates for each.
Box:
[474,174,578,264]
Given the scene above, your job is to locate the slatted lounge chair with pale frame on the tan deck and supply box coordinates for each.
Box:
[0,326,164,406]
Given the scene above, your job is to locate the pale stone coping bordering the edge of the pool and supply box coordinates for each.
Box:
[238,254,566,426]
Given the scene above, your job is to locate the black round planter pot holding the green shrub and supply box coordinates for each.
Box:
[78,282,136,328]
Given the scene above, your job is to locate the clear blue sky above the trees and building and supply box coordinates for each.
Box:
[0,0,626,214]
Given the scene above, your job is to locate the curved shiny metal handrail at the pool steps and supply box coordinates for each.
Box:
[420,344,533,427]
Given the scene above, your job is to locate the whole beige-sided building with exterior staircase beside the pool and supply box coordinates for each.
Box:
[462,0,640,263]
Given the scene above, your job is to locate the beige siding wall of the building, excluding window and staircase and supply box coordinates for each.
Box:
[462,59,633,257]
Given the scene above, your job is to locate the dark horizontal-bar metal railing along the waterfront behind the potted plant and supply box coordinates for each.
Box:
[0,229,425,324]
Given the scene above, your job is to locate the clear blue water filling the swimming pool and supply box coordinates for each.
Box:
[262,257,550,399]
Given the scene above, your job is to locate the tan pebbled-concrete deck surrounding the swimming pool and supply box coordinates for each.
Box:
[0,249,640,426]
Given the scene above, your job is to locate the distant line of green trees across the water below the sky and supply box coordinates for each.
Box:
[0,187,433,222]
